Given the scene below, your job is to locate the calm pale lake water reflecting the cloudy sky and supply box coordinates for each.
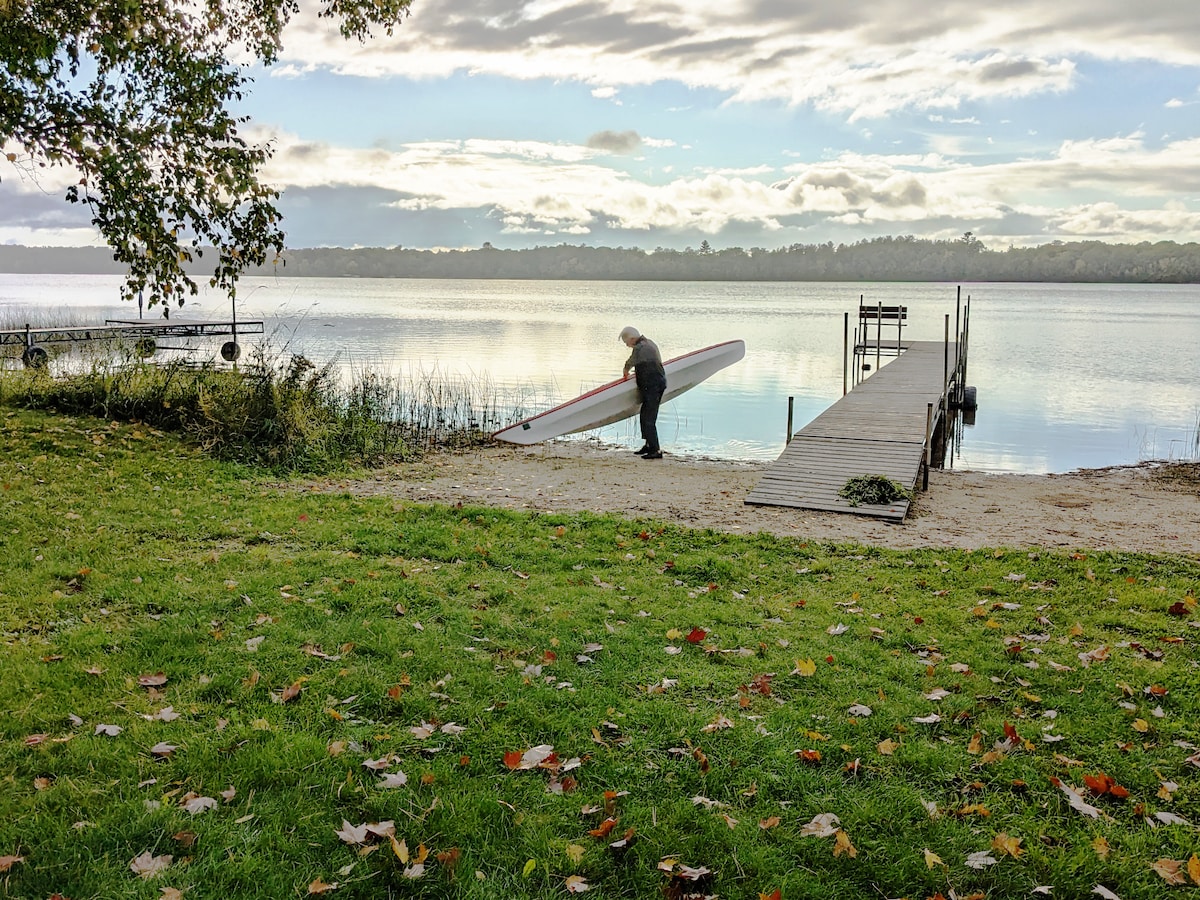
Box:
[0,275,1200,474]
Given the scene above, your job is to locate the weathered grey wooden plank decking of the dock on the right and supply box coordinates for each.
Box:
[745,341,956,522]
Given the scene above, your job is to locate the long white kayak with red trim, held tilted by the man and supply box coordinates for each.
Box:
[492,341,746,444]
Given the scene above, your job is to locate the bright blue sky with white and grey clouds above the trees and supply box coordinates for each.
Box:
[7,0,1200,251]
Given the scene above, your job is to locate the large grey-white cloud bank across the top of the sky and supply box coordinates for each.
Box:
[277,0,1200,120]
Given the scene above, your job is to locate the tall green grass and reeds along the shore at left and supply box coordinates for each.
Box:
[0,346,540,472]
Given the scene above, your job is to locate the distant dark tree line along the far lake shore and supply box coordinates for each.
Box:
[0,232,1200,284]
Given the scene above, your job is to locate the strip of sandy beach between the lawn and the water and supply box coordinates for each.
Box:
[314,440,1200,554]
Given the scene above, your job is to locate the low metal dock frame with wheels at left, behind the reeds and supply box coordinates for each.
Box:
[0,319,263,368]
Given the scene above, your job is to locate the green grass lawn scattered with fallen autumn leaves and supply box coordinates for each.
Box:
[0,409,1200,900]
